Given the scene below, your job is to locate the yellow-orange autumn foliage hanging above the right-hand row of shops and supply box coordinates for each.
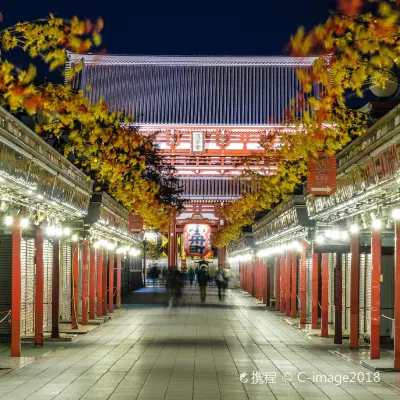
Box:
[214,0,400,247]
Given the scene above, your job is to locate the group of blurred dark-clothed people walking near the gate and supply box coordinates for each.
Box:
[148,260,228,305]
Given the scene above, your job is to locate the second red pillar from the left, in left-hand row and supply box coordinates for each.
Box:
[35,225,44,347]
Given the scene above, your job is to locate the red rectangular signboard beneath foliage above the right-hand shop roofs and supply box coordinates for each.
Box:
[307,153,336,196]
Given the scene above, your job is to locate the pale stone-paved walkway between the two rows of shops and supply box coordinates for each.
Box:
[0,288,400,400]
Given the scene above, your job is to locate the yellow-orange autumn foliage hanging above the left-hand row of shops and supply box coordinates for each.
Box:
[0,15,180,229]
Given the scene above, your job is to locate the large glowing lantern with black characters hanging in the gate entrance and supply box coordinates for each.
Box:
[183,224,211,257]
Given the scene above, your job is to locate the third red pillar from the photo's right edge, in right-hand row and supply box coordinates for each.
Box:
[350,232,360,349]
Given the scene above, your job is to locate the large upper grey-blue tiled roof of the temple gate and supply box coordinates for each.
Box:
[67,54,314,126]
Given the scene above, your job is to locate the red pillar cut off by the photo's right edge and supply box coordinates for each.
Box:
[394,221,400,371]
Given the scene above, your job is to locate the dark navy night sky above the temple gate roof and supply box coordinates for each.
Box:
[0,0,336,55]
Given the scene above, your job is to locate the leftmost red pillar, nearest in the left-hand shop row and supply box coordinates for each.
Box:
[10,216,22,357]
